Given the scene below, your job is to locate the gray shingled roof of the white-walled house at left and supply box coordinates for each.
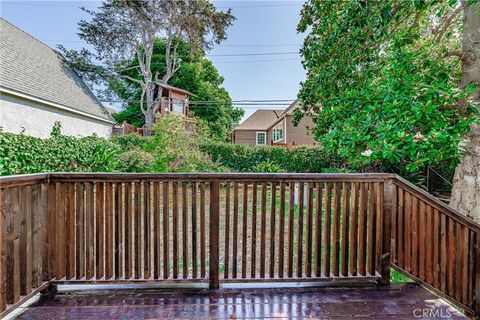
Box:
[0,18,113,122]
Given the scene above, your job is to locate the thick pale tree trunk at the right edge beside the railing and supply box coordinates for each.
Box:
[450,3,480,222]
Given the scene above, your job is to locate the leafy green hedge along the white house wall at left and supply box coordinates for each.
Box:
[0,123,120,175]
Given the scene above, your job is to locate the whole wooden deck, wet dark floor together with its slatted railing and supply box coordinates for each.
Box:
[0,173,480,319]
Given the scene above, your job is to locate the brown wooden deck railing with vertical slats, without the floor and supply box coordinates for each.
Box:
[0,173,480,314]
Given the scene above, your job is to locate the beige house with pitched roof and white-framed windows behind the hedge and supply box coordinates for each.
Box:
[232,101,316,145]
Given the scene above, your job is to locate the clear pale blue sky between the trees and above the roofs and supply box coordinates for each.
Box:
[0,0,305,120]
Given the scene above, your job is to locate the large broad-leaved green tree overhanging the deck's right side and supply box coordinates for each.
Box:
[298,0,480,215]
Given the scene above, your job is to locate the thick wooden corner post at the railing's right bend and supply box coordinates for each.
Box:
[380,179,396,285]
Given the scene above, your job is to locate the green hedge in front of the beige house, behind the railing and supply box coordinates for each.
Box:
[201,142,343,172]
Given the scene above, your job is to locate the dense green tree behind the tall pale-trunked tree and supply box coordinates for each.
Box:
[110,39,243,139]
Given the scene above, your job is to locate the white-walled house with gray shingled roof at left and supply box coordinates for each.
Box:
[0,18,114,138]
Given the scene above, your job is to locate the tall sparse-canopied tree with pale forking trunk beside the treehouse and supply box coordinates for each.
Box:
[61,0,235,134]
